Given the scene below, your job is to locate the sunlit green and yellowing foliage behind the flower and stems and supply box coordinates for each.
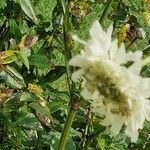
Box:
[0,0,150,150]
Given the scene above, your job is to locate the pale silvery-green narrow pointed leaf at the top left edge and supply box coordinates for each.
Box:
[18,0,37,23]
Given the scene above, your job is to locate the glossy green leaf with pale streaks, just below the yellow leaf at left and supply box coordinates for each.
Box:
[0,66,26,89]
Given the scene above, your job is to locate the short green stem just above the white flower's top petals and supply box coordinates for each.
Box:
[100,0,113,24]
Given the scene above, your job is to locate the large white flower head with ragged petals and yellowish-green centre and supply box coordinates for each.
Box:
[69,21,150,142]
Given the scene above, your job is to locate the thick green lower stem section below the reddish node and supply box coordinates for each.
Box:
[57,108,76,150]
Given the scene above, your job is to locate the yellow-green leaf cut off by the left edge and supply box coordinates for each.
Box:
[0,50,17,64]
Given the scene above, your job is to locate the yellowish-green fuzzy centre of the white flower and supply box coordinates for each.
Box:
[84,62,131,116]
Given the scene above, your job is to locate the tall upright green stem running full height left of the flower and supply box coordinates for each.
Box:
[58,0,77,150]
